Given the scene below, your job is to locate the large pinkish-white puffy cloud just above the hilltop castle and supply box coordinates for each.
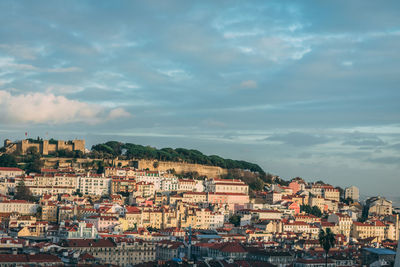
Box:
[0,91,129,124]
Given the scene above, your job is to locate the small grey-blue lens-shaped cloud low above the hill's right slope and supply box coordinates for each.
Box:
[264,132,330,146]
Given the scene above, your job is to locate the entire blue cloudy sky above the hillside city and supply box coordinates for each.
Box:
[0,0,400,201]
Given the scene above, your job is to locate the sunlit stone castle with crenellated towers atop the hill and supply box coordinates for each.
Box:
[4,139,85,155]
